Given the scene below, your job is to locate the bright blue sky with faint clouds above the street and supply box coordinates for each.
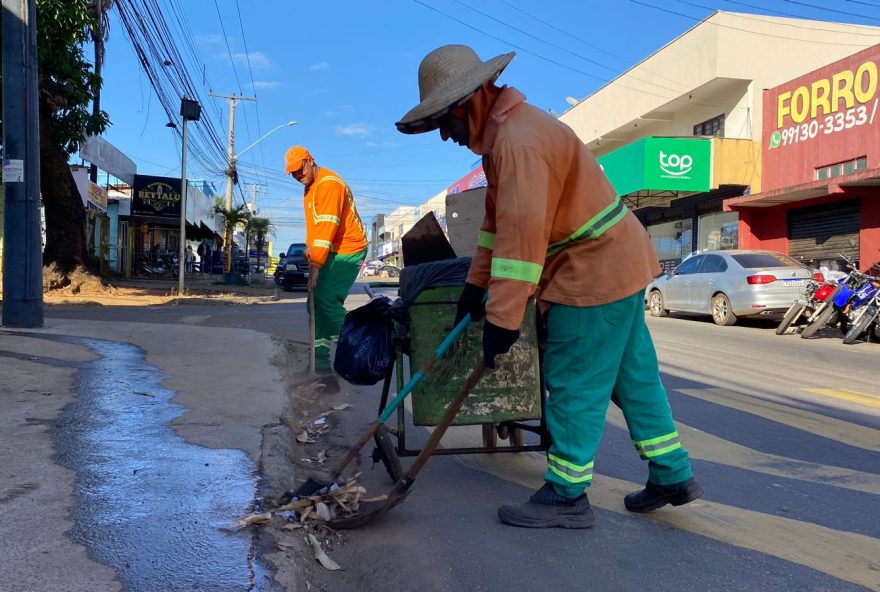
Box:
[94,0,880,251]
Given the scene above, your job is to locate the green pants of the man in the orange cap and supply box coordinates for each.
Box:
[309,251,366,370]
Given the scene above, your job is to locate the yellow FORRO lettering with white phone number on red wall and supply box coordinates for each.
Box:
[769,53,880,149]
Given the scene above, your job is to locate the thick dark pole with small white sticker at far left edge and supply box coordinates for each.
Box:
[2,0,43,328]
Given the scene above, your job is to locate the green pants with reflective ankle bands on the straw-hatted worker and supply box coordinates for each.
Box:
[544,292,692,497]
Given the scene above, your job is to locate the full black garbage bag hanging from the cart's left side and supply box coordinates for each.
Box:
[333,296,396,385]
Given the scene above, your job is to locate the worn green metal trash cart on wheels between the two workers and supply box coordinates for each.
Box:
[368,284,549,481]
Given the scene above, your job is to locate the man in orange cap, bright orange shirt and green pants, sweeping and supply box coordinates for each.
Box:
[284,146,367,392]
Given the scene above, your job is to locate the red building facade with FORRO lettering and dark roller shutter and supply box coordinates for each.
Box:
[725,45,880,269]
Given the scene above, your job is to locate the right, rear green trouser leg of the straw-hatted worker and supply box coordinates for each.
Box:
[614,291,693,485]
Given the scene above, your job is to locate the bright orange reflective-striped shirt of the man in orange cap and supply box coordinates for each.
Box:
[304,167,367,268]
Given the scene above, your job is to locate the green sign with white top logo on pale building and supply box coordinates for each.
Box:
[599,137,712,195]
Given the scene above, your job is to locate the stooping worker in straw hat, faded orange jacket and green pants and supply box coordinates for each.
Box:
[397,45,703,528]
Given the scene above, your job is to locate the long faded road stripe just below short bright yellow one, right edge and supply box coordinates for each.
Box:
[675,388,880,452]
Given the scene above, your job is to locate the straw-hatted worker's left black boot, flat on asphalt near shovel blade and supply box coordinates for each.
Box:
[498,483,596,528]
